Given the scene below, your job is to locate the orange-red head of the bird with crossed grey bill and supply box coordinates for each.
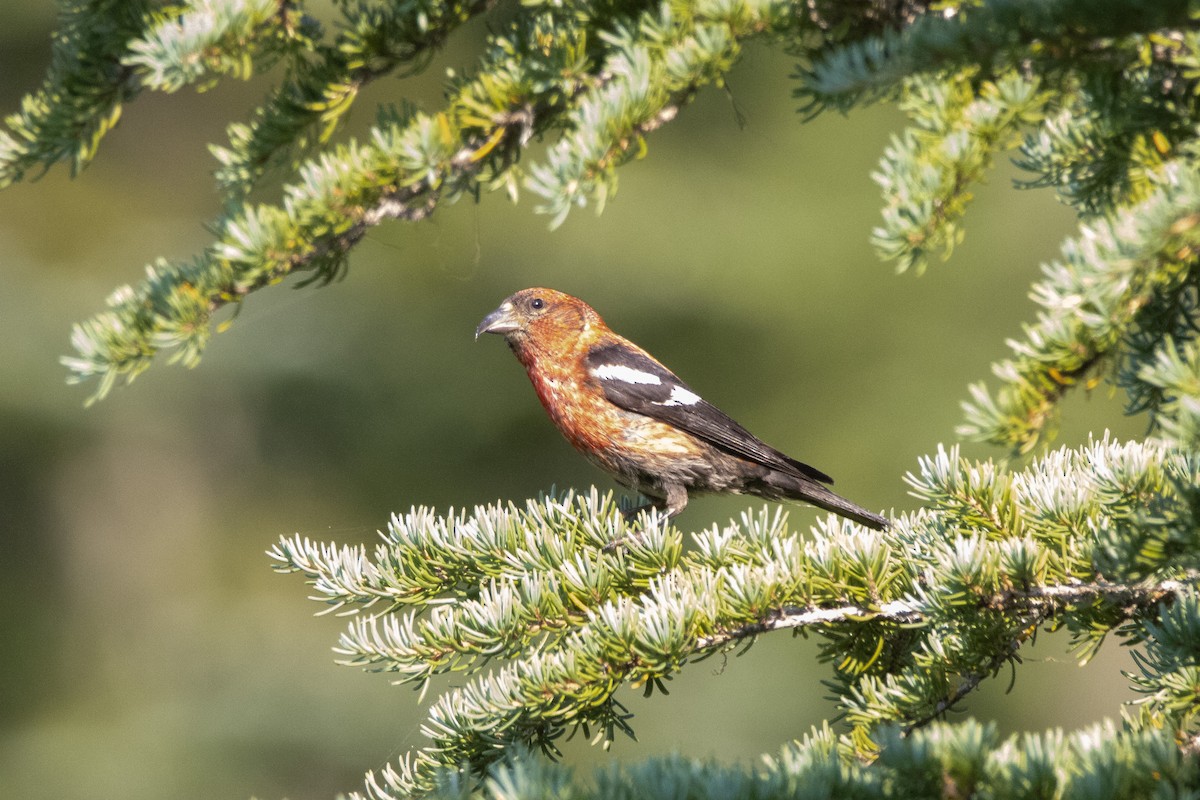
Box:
[475,288,604,354]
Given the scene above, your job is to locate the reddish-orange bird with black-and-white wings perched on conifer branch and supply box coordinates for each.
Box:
[475,288,890,530]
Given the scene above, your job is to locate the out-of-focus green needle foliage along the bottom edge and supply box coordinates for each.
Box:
[396,722,1200,800]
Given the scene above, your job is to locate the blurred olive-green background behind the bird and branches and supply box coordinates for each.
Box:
[0,0,1144,799]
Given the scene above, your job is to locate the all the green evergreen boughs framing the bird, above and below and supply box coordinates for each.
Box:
[9,0,1200,798]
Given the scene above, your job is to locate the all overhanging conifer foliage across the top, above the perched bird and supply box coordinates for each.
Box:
[0,0,1200,422]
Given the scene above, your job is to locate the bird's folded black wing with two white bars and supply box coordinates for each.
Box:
[587,343,833,483]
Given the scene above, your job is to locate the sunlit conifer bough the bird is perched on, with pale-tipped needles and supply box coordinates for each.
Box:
[271,439,1200,794]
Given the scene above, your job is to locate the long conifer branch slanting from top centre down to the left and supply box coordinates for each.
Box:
[54,0,806,399]
